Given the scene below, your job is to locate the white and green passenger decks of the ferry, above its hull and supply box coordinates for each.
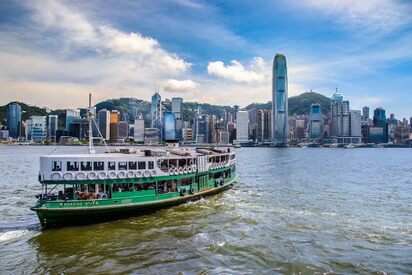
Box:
[36,148,236,208]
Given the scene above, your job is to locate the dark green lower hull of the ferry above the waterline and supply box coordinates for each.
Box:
[31,179,236,228]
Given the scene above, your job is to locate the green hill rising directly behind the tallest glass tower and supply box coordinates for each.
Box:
[246,92,331,115]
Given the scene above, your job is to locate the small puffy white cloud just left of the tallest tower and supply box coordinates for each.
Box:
[207,57,265,83]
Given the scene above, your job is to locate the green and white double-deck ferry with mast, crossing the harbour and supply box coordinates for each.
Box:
[31,95,236,227]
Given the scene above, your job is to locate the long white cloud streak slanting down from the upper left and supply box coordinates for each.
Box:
[30,1,191,74]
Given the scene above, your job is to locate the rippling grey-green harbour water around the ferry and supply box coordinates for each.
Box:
[0,146,412,274]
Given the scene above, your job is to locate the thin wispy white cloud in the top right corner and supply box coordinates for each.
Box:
[299,0,411,32]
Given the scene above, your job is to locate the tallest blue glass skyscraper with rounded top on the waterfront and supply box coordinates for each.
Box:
[272,53,289,145]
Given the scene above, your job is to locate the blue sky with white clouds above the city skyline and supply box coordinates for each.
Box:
[0,0,412,119]
